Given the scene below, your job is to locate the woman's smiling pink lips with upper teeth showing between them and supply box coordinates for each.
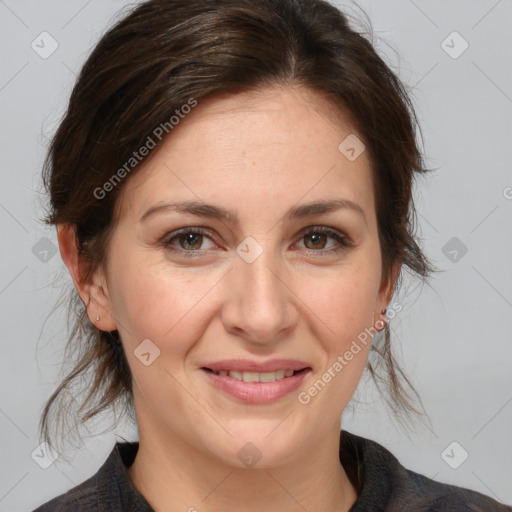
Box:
[201,359,311,404]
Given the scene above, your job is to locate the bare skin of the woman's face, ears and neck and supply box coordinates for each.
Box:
[58,86,400,512]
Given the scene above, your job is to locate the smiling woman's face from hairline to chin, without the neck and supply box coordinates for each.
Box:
[88,87,392,466]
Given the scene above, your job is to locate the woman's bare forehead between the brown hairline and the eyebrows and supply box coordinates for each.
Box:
[114,87,373,223]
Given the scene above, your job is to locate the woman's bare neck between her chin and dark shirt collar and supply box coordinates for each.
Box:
[128,425,357,512]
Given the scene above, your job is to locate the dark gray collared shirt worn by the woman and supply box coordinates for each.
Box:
[33,430,512,512]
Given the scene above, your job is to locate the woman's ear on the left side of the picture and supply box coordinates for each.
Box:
[57,224,117,331]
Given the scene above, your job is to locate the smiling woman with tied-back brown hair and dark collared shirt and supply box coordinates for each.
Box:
[37,0,511,511]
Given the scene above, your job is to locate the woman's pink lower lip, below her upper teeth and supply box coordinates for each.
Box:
[201,368,311,404]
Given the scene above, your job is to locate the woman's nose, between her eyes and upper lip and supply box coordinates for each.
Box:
[221,244,299,345]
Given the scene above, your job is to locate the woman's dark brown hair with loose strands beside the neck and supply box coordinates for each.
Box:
[40,0,434,452]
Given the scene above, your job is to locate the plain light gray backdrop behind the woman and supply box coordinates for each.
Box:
[0,0,512,512]
